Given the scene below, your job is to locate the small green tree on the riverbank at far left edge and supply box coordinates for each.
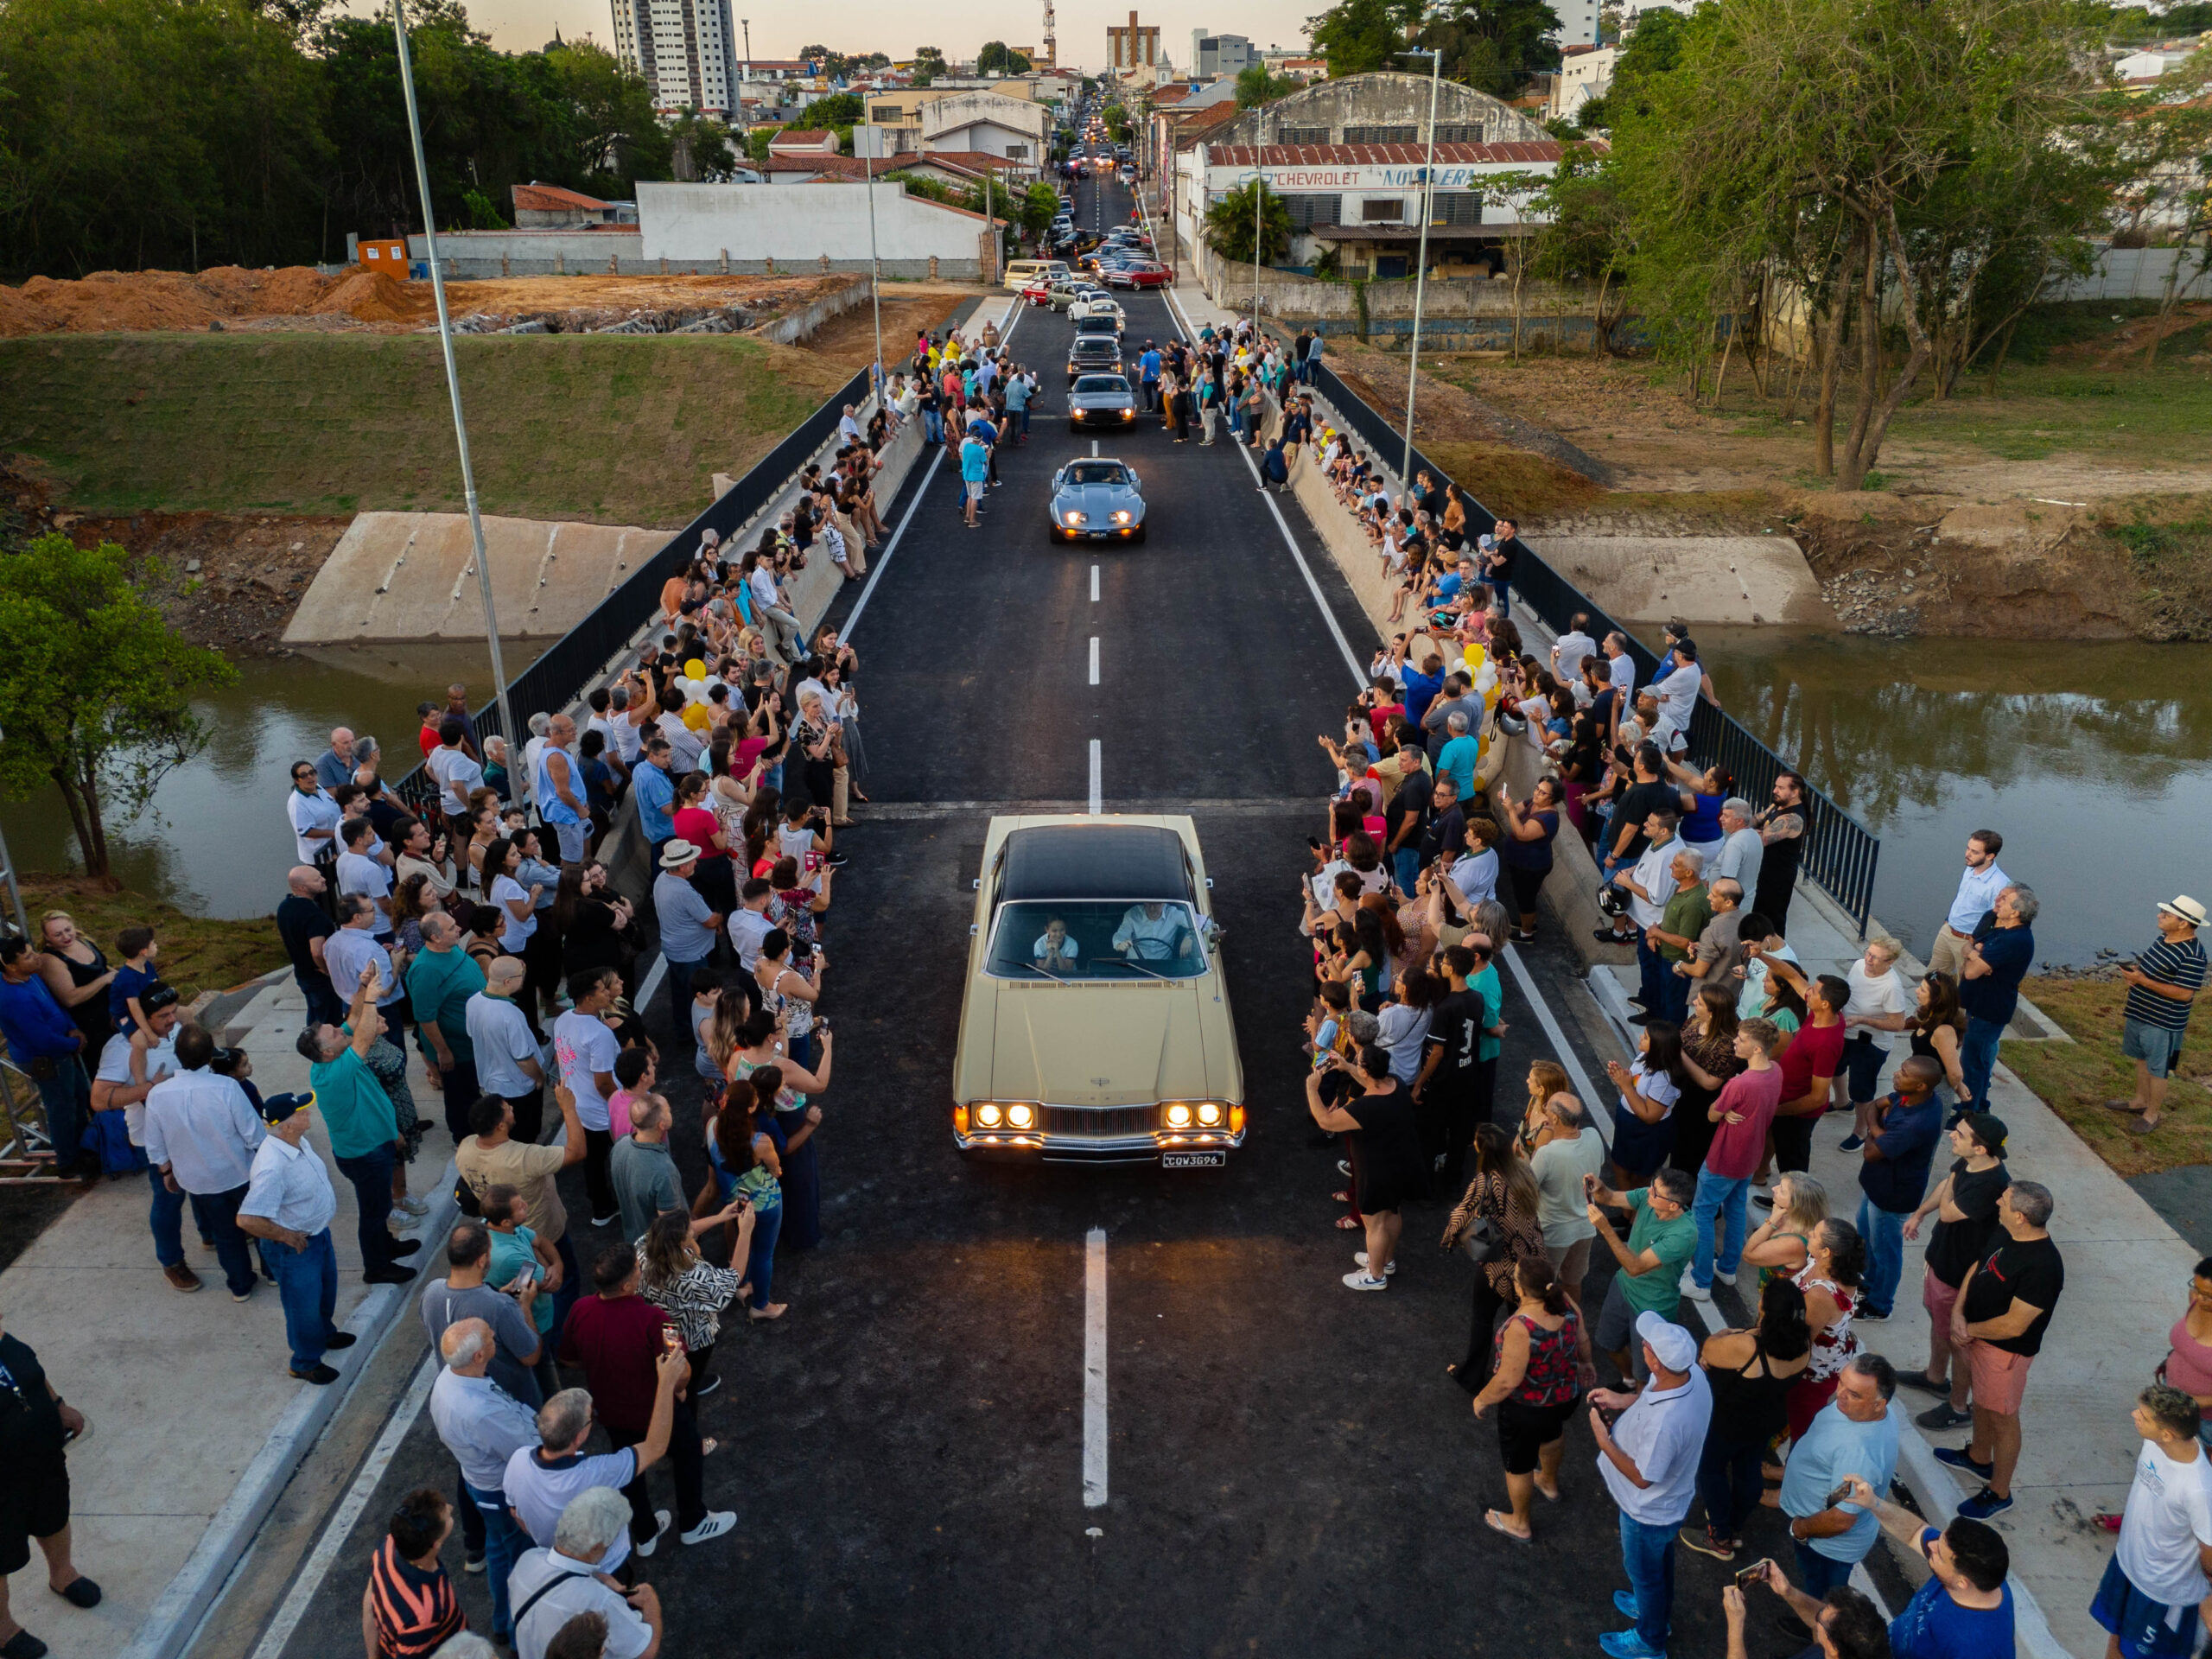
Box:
[0,533,237,880]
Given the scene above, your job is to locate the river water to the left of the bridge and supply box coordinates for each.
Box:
[0,639,508,916]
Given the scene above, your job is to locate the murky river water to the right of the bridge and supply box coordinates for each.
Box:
[1699,628,2212,964]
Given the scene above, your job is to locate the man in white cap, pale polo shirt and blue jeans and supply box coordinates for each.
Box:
[1591,1312,1712,1659]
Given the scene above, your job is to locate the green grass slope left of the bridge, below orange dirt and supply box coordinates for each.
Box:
[0,334,847,524]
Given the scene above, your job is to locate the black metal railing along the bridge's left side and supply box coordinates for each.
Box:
[394,370,869,827]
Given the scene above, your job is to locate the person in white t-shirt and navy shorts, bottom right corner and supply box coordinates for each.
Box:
[2090,1382,2212,1655]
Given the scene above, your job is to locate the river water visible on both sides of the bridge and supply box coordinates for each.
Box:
[0,628,2212,963]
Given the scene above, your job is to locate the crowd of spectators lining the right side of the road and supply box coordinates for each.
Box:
[1300,535,2212,1659]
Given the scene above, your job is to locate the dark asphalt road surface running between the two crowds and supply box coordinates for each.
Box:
[254,166,1866,1659]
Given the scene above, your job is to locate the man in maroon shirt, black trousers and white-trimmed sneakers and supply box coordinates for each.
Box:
[560,1245,736,1546]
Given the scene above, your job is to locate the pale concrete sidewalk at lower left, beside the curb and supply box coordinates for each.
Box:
[0,971,454,1659]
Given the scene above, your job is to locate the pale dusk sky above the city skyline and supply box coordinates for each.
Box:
[372,0,1325,68]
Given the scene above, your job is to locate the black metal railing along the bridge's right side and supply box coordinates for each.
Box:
[1314,363,1883,933]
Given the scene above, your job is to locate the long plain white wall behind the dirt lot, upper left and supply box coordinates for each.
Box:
[637,183,984,281]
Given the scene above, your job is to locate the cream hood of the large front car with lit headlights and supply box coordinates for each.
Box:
[991,980,1208,1106]
